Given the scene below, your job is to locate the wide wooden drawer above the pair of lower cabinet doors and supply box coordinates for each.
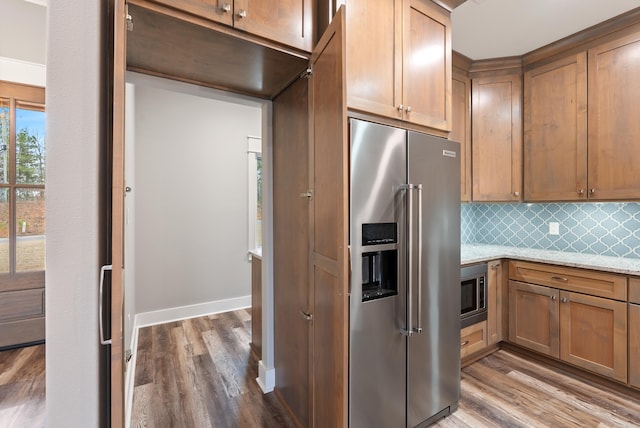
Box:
[509,261,627,301]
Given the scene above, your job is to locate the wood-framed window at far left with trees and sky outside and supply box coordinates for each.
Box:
[0,82,46,277]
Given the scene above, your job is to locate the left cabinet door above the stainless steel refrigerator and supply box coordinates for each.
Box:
[345,0,402,119]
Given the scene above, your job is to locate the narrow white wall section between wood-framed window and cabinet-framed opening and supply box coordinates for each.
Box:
[45,0,102,428]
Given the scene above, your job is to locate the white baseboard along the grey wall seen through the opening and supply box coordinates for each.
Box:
[135,295,251,328]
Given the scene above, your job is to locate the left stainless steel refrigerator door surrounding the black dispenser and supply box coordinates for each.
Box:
[349,120,406,428]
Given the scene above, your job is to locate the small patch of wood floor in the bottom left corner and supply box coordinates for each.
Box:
[0,345,45,428]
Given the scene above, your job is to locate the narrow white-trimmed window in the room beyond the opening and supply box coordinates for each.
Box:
[247,137,262,251]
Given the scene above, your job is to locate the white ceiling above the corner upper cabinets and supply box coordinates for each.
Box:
[451,0,640,60]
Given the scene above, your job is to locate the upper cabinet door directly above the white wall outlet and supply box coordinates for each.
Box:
[524,52,587,201]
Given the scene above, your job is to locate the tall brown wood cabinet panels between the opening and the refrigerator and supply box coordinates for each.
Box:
[273,9,349,427]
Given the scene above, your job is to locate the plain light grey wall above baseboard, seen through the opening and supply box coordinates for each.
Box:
[133,76,262,313]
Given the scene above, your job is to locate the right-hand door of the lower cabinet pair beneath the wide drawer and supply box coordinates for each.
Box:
[560,291,627,383]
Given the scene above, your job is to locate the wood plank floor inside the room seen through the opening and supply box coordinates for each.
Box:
[131,310,294,428]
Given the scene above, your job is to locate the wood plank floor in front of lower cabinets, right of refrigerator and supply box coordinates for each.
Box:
[434,350,640,428]
